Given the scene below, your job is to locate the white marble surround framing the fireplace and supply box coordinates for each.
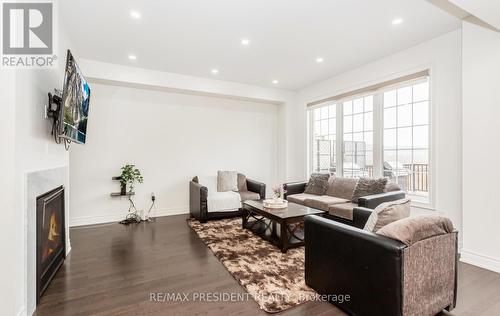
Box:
[25,166,71,315]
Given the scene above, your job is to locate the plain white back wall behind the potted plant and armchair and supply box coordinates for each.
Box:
[70,84,279,225]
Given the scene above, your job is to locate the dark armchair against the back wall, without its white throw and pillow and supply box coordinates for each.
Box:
[189,173,266,223]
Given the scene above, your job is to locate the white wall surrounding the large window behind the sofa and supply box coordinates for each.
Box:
[292,30,462,237]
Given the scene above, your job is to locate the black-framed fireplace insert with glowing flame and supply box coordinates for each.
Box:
[36,186,66,304]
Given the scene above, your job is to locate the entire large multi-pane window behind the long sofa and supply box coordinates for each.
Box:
[308,71,430,203]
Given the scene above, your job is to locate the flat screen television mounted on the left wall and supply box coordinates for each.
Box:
[60,50,90,144]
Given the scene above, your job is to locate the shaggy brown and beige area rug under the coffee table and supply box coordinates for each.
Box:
[188,218,316,313]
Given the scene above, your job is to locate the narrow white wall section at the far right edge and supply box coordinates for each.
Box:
[462,22,500,272]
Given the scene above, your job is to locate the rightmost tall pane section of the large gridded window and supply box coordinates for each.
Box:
[383,79,429,201]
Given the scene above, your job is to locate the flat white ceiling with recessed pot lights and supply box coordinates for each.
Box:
[59,0,460,89]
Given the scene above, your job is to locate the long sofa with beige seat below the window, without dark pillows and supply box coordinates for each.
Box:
[284,176,406,228]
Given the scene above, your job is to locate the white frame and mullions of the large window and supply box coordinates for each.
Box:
[307,67,436,209]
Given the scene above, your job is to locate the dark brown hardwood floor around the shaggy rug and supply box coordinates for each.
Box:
[35,216,500,316]
